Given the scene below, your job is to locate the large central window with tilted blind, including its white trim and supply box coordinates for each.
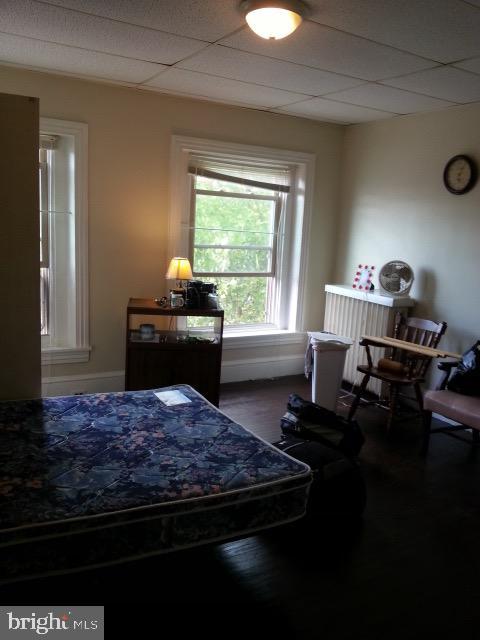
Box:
[168,136,314,346]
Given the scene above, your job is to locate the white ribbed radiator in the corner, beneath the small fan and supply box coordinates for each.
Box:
[323,284,414,395]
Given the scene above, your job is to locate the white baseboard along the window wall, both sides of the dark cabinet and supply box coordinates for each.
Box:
[42,355,304,396]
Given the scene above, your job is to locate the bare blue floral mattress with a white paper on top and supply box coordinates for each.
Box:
[0,385,311,583]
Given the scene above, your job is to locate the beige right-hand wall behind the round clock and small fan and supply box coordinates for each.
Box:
[335,105,480,358]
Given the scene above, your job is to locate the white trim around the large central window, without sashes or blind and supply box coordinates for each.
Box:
[167,135,315,349]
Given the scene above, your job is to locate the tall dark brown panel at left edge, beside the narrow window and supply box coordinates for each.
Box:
[0,93,40,400]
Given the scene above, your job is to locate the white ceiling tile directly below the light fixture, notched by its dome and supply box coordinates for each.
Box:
[220,21,433,80]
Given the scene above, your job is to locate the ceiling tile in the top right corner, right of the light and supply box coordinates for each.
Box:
[309,0,480,62]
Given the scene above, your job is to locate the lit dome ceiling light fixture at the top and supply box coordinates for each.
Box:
[240,0,308,40]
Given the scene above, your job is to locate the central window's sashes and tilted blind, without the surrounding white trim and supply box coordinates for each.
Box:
[189,156,291,327]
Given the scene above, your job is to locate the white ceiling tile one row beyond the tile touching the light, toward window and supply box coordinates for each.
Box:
[177,45,362,96]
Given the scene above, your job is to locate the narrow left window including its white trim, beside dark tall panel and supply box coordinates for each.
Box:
[39,118,90,364]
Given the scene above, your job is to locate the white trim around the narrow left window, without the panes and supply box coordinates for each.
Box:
[40,117,91,364]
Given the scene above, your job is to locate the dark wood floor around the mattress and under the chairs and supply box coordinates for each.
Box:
[0,376,480,640]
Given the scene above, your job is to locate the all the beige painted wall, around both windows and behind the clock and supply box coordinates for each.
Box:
[0,67,480,392]
